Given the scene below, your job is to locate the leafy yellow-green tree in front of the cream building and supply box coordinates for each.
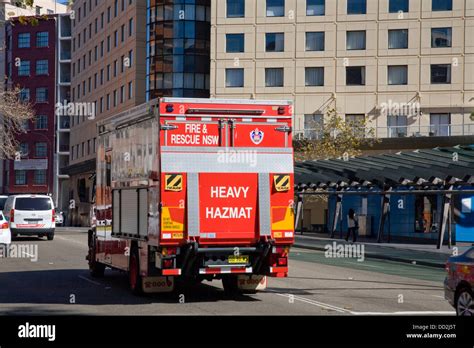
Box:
[294,108,378,161]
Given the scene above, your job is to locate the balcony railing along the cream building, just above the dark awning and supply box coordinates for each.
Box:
[294,123,474,140]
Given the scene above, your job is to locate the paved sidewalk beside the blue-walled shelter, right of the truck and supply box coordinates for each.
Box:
[294,233,468,268]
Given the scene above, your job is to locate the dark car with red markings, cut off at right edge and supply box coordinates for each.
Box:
[444,248,474,316]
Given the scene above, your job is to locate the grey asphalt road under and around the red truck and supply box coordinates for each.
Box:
[0,229,454,315]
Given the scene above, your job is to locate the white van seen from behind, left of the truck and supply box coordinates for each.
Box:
[3,195,56,240]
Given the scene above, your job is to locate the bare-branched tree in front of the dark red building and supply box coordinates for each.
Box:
[0,87,35,159]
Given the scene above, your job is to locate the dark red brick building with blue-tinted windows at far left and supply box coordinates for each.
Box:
[4,15,56,194]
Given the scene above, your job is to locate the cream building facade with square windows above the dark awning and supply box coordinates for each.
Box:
[211,0,474,147]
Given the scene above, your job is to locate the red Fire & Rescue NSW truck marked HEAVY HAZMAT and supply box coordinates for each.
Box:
[87,98,294,294]
